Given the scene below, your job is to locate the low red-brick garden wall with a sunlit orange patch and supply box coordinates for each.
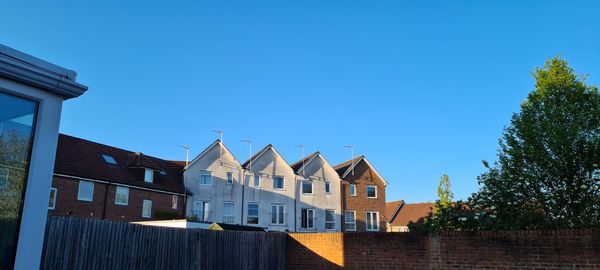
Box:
[286,230,600,269]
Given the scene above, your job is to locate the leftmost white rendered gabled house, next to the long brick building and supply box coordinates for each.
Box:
[183,140,243,224]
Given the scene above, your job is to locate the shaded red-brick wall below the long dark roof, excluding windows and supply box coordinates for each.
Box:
[48,176,185,221]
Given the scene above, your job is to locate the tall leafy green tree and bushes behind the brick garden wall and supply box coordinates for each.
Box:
[424,58,600,231]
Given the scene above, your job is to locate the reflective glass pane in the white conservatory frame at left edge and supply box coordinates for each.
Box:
[0,92,37,269]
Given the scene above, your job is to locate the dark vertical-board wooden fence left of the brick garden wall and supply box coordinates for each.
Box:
[41,217,286,269]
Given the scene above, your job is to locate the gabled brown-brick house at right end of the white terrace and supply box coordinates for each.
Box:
[334,156,387,232]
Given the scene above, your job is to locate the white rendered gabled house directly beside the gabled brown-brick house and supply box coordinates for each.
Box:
[291,152,342,232]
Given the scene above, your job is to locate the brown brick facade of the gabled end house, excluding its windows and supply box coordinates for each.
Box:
[341,161,387,232]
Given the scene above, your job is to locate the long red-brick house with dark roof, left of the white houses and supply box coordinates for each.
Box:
[48,134,185,221]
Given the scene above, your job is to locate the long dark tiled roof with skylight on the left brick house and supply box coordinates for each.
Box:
[54,134,185,193]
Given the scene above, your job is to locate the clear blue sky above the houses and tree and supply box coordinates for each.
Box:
[0,0,600,202]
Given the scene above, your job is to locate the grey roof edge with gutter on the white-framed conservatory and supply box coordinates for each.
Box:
[0,44,87,99]
